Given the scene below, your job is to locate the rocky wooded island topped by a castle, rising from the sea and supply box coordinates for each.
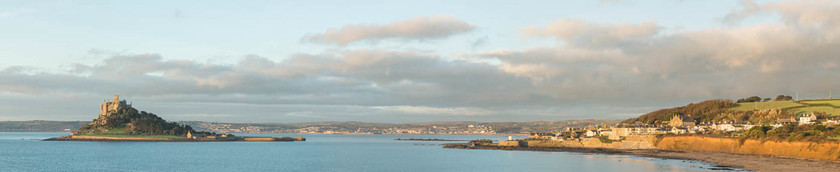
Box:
[45,95,306,142]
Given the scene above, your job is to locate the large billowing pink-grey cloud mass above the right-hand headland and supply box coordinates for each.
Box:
[465,1,840,101]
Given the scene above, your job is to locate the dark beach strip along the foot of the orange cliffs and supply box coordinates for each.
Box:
[444,143,840,172]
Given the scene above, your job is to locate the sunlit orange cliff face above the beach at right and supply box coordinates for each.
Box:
[656,136,840,160]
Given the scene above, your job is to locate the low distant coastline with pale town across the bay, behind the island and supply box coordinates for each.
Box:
[0,120,620,135]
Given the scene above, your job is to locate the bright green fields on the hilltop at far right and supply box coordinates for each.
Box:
[730,99,840,116]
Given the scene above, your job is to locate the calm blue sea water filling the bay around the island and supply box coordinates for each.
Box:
[0,133,732,172]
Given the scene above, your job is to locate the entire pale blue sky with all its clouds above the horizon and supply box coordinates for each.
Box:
[0,0,840,123]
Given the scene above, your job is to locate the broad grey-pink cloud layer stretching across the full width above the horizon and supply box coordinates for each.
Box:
[0,1,840,122]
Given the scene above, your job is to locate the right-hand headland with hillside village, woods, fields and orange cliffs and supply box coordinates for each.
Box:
[444,95,840,171]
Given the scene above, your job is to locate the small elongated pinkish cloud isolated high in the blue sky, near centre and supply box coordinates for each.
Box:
[301,15,475,46]
